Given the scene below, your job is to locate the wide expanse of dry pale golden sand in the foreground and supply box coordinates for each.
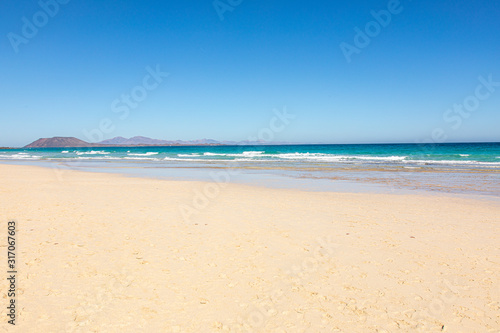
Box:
[0,165,500,332]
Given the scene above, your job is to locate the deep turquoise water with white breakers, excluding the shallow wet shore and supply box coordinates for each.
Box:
[0,143,500,168]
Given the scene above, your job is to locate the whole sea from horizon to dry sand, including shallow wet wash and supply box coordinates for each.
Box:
[0,143,500,196]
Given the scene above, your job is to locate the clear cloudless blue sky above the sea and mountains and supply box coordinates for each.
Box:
[0,0,500,147]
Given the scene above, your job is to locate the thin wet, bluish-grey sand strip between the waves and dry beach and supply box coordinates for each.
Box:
[0,160,500,201]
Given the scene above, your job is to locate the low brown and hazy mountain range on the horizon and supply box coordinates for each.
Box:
[23,136,283,148]
